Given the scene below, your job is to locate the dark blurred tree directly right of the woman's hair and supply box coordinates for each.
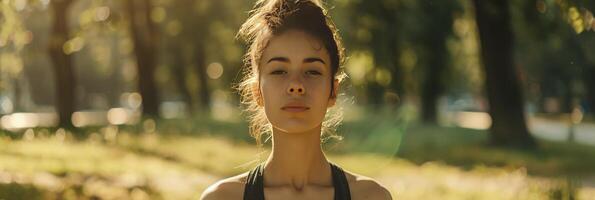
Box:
[346,0,406,107]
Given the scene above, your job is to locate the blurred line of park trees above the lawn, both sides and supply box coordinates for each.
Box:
[0,0,595,148]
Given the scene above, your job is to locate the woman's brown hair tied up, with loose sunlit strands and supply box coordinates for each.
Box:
[237,0,345,145]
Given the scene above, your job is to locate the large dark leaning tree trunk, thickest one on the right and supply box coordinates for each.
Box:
[473,0,536,148]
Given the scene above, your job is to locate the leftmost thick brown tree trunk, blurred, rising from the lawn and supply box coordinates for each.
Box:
[49,0,75,128]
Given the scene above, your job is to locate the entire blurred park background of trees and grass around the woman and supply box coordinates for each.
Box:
[0,0,595,199]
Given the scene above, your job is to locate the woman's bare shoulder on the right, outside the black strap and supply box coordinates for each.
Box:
[345,171,392,200]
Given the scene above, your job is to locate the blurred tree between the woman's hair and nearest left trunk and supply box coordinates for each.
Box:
[162,0,235,112]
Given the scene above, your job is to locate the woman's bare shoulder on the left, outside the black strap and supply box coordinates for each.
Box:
[200,172,248,200]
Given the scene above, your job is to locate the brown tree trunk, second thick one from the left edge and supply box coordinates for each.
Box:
[127,0,159,117]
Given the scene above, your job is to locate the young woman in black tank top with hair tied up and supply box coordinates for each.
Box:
[201,0,391,200]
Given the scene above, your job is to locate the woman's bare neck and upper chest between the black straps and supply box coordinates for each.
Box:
[264,126,332,190]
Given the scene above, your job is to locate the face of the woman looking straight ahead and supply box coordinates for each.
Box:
[259,30,338,133]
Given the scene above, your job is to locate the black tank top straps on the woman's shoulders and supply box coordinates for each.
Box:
[244,163,351,200]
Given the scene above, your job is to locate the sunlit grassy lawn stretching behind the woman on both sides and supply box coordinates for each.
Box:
[0,111,595,199]
